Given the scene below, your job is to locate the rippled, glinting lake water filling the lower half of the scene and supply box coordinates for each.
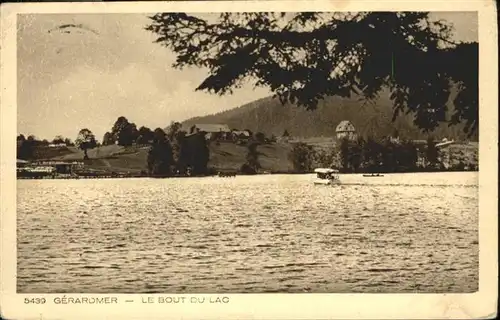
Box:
[17,172,479,293]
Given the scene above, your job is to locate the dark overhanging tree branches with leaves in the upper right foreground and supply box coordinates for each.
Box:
[146,12,478,134]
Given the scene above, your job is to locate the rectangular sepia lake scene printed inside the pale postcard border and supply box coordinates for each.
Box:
[2,0,496,318]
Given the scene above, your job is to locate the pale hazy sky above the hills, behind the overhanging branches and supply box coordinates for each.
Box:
[17,12,478,140]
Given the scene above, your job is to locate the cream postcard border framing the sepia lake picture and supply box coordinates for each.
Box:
[0,0,498,319]
